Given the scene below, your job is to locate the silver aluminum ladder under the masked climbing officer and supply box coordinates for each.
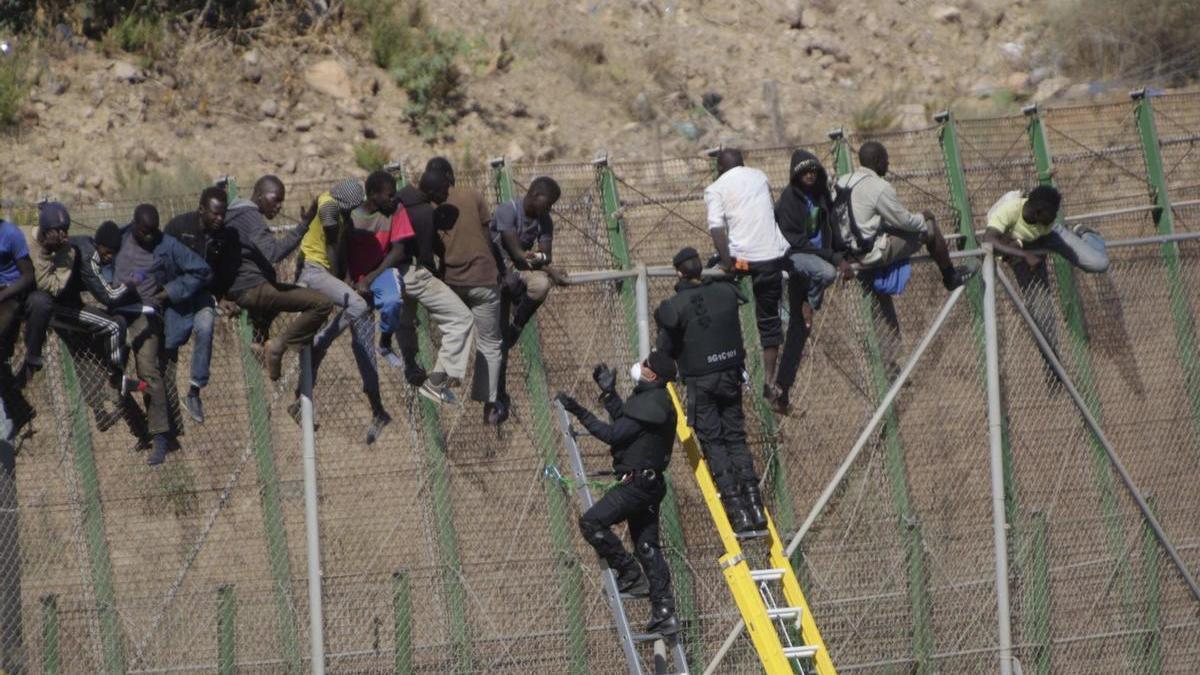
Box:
[554,401,689,675]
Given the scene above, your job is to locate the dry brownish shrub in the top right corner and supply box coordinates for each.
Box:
[1048,0,1200,84]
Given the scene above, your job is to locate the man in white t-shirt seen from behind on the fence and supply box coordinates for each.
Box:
[704,148,787,395]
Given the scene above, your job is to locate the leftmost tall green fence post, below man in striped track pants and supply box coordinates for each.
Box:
[59,341,125,675]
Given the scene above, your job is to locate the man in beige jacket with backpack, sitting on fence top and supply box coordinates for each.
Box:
[838,141,974,291]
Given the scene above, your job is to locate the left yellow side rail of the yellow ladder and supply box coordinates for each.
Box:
[667,384,806,675]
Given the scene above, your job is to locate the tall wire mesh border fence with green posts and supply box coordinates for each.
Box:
[0,94,1200,674]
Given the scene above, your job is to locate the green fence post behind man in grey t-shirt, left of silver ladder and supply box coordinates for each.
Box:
[492,160,588,675]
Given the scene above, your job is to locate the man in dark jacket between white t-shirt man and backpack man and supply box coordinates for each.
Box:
[767,150,845,414]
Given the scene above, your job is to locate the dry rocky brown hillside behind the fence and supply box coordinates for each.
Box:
[0,0,1123,205]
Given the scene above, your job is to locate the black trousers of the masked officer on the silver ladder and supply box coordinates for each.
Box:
[580,472,674,610]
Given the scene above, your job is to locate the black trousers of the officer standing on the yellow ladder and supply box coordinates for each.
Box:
[688,368,758,495]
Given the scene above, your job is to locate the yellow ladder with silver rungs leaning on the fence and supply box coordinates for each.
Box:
[667,384,836,675]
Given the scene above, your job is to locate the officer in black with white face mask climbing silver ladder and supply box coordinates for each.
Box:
[557,352,679,635]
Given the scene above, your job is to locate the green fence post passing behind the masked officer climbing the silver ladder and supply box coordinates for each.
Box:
[596,157,704,668]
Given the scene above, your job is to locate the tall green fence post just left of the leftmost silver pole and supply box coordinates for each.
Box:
[238,312,301,675]
